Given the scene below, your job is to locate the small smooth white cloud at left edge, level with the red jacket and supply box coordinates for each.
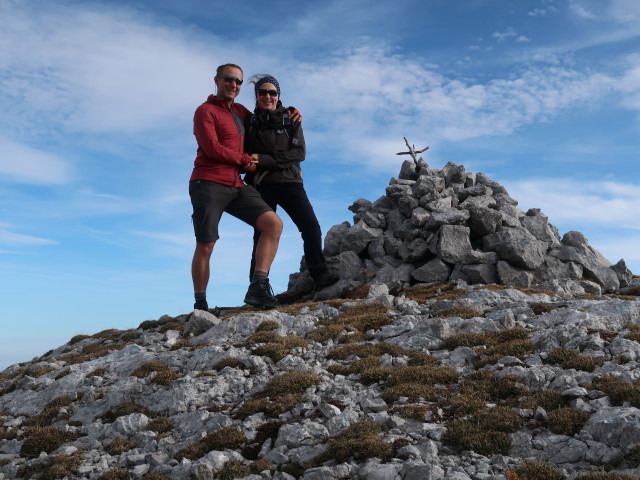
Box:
[0,137,73,185]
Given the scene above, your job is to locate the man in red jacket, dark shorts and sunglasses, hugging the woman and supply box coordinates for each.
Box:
[189,64,282,310]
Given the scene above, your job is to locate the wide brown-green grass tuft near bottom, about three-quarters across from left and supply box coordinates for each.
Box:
[443,406,521,456]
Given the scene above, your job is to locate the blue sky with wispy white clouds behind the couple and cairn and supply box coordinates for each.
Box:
[0,0,640,368]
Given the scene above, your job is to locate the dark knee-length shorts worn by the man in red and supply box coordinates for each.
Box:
[189,180,273,243]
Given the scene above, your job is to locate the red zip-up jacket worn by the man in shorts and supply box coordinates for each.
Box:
[189,95,251,187]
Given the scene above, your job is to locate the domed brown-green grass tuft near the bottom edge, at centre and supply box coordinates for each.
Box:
[313,420,393,465]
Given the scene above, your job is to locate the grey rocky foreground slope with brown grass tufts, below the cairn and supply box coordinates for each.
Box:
[0,278,640,480]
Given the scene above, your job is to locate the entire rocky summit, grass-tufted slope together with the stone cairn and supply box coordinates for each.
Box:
[0,160,640,480]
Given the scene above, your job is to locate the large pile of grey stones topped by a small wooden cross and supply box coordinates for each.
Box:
[288,158,632,299]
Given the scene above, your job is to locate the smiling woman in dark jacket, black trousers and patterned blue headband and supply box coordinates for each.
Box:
[244,75,338,290]
